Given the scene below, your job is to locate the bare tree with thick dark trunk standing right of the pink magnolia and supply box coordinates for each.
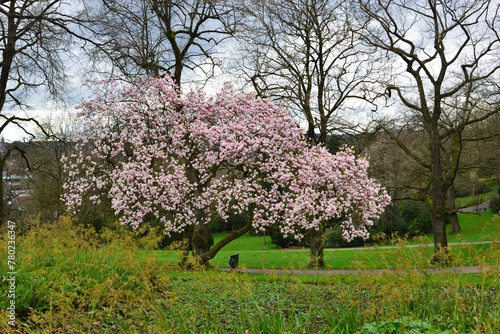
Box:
[355,0,500,262]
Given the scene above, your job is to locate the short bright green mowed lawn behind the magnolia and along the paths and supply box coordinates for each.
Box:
[155,211,500,269]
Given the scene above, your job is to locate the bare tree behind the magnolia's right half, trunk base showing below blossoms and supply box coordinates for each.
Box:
[239,0,380,266]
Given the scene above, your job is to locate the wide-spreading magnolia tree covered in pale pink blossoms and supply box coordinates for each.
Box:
[64,78,389,263]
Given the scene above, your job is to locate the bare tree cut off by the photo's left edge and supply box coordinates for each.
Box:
[0,0,90,224]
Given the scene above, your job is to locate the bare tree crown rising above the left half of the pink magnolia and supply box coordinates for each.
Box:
[84,0,238,85]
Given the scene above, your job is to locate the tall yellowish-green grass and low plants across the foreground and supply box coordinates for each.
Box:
[0,218,500,334]
